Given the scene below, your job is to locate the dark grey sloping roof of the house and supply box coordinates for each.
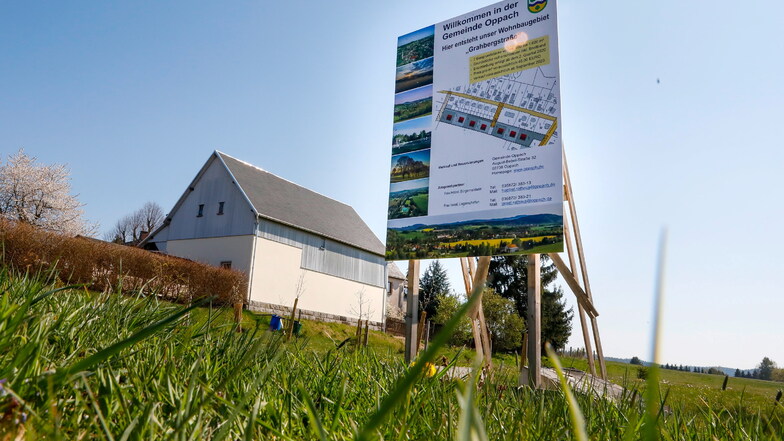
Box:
[215,151,385,256]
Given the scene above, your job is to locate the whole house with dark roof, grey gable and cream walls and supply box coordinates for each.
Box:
[141,151,387,326]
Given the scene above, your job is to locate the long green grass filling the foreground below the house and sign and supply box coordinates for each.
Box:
[0,269,784,441]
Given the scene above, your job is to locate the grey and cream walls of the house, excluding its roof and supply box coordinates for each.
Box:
[143,152,387,323]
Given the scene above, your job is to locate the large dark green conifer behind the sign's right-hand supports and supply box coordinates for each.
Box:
[487,255,574,350]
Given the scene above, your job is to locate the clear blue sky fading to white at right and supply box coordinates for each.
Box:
[0,0,784,368]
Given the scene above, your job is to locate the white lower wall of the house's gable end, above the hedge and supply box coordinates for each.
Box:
[166,235,255,274]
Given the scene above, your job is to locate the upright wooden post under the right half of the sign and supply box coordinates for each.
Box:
[527,254,542,389]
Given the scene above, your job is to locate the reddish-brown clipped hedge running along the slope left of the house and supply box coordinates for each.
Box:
[0,220,247,304]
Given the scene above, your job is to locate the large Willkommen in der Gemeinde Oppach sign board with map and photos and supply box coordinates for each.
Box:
[387,0,563,260]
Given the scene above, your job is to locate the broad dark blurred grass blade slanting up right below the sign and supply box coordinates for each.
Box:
[356,287,481,441]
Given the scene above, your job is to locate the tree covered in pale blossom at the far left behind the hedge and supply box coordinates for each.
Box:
[0,149,97,236]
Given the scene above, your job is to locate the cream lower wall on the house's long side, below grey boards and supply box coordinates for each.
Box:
[251,238,386,322]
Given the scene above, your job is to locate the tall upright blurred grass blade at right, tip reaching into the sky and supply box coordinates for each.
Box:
[641,229,667,441]
